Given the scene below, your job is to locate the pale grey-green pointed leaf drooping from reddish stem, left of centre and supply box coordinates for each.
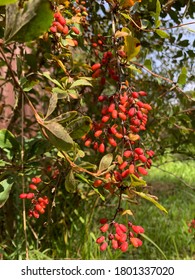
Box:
[42,122,75,151]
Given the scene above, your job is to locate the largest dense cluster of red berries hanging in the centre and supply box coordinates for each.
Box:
[84,83,154,188]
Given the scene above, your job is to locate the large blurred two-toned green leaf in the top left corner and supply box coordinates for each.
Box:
[4,0,53,43]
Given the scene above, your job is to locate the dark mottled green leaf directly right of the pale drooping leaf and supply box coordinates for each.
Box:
[67,116,91,139]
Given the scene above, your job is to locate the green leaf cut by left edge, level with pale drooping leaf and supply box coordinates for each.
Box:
[0,129,19,150]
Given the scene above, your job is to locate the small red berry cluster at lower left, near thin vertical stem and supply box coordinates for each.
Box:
[19,177,49,219]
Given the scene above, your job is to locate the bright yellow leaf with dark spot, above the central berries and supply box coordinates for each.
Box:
[121,27,141,60]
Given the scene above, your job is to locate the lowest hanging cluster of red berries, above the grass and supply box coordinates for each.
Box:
[96,218,144,252]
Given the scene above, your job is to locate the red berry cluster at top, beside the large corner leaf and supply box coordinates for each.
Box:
[50,12,80,46]
